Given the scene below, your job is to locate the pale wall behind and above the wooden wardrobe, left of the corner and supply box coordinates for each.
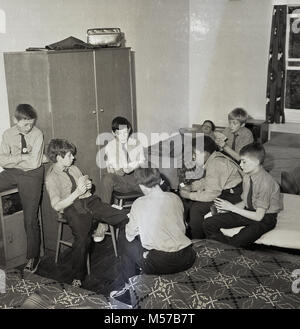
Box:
[0,0,189,141]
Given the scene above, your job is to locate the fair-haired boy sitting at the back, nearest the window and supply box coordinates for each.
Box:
[215,108,253,162]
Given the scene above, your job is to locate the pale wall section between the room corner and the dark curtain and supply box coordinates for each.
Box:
[189,0,273,125]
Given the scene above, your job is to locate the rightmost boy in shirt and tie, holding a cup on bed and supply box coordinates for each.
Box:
[204,143,283,247]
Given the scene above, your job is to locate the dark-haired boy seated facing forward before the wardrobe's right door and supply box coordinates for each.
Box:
[99,117,145,203]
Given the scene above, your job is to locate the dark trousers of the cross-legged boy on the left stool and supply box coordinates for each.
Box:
[64,195,128,280]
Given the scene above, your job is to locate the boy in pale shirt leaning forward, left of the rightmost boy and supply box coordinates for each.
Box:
[180,136,242,239]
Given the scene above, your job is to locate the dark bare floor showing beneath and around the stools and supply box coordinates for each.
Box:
[36,236,122,296]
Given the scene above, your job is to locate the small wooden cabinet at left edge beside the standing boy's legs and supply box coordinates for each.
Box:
[0,188,27,269]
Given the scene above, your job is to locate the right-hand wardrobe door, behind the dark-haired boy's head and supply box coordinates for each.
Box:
[95,48,135,133]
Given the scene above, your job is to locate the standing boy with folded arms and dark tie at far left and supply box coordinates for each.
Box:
[0,104,44,273]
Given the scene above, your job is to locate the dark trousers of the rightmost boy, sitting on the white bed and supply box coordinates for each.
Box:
[204,212,277,248]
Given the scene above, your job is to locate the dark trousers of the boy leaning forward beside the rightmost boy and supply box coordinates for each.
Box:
[189,183,242,239]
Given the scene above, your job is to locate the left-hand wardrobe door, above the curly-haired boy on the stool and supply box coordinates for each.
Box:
[49,51,99,186]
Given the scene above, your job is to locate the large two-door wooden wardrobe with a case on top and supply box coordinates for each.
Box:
[4,48,137,250]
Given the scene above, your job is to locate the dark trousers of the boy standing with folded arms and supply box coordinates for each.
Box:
[0,166,44,259]
